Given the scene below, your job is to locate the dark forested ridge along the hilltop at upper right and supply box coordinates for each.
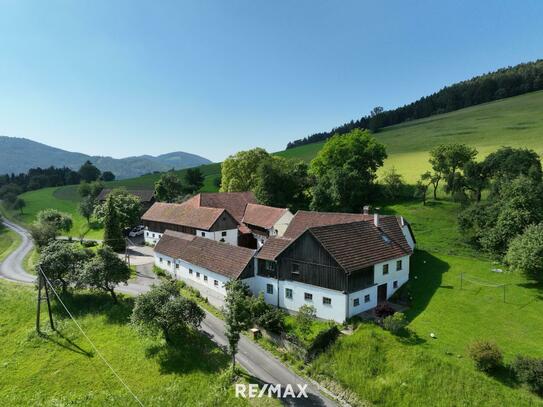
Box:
[287,59,543,149]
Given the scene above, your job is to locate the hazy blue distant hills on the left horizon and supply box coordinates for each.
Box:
[0,136,211,179]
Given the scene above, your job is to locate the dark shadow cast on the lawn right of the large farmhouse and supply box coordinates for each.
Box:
[406,250,450,321]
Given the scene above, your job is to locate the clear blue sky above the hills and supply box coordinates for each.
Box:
[0,0,543,161]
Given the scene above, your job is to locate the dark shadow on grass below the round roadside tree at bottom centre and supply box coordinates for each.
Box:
[145,330,230,375]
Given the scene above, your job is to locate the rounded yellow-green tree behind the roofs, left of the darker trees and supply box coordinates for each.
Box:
[220,148,271,192]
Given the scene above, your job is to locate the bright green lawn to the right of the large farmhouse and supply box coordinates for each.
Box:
[310,200,543,406]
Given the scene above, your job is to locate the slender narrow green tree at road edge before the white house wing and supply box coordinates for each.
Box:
[224,280,252,371]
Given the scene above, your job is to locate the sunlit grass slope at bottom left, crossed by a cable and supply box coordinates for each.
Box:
[0,281,277,406]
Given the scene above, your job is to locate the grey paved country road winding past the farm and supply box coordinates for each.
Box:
[0,219,337,406]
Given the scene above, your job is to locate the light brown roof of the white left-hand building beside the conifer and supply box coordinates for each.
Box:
[141,202,228,230]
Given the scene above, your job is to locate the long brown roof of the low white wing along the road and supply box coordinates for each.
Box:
[155,230,254,279]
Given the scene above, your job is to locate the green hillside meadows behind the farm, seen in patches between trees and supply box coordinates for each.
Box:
[6,88,543,237]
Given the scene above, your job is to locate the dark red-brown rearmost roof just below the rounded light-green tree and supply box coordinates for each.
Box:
[183,192,257,223]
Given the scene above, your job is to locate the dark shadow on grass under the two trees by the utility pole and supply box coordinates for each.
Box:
[52,291,134,324]
